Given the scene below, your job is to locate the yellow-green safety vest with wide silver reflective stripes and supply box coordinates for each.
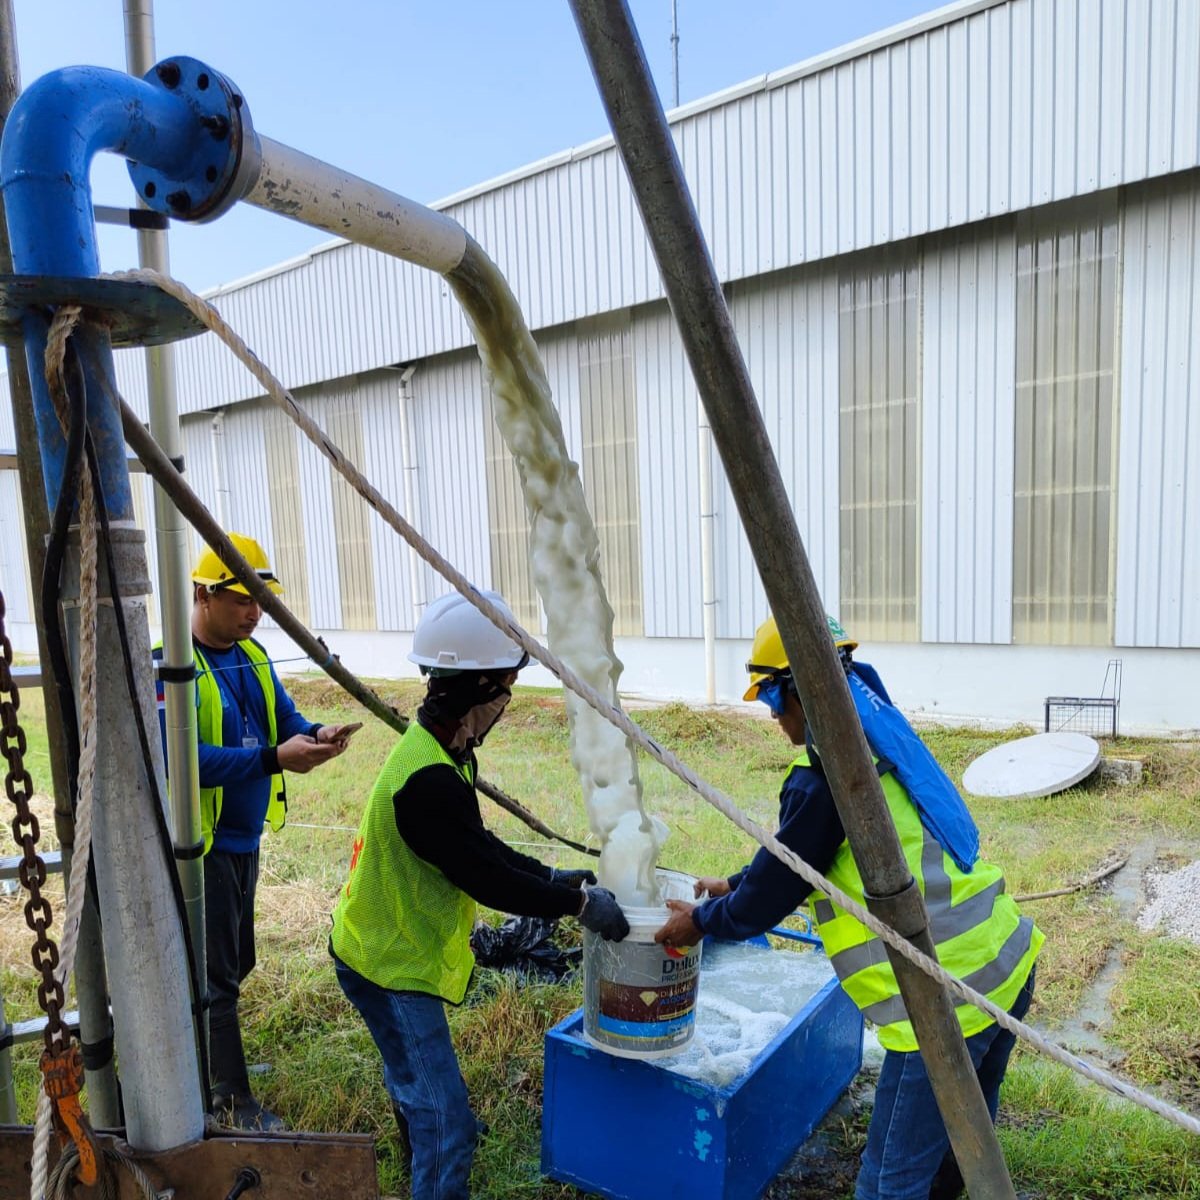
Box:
[792,752,1045,1050]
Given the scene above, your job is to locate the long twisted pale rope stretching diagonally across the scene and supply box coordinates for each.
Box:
[104,270,1200,1134]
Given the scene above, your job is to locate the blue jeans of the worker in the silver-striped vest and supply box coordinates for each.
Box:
[854,971,1034,1200]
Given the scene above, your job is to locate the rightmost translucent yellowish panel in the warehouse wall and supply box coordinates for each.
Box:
[1013,191,1120,646]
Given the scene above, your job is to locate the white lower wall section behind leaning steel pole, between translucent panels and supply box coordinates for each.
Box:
[634,269,839,637]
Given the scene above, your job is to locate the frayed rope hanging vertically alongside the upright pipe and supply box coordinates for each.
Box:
[30,305,98,1200]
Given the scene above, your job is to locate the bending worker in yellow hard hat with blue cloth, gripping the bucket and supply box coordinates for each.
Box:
[655,617,1043,1200]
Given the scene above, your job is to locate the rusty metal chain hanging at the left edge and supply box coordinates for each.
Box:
[0,592,70,1054]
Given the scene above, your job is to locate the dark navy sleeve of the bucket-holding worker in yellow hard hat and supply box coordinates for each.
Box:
[692,767,846,941]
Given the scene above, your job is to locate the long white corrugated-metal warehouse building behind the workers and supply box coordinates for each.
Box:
[0,0,1200,731]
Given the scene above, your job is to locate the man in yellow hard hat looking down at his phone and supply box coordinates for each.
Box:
[155,533,358,1130]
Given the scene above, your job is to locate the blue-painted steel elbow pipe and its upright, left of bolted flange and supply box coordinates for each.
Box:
[0,67,240,521]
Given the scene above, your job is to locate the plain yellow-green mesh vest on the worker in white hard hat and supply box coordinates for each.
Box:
[332,721,475,1004]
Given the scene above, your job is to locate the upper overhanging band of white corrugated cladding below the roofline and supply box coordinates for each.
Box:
[110,0,1200,422]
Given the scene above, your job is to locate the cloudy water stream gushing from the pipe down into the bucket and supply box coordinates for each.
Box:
[449,242,667,906]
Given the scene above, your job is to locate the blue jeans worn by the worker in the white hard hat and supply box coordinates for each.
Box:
[334,955,478,1200]
